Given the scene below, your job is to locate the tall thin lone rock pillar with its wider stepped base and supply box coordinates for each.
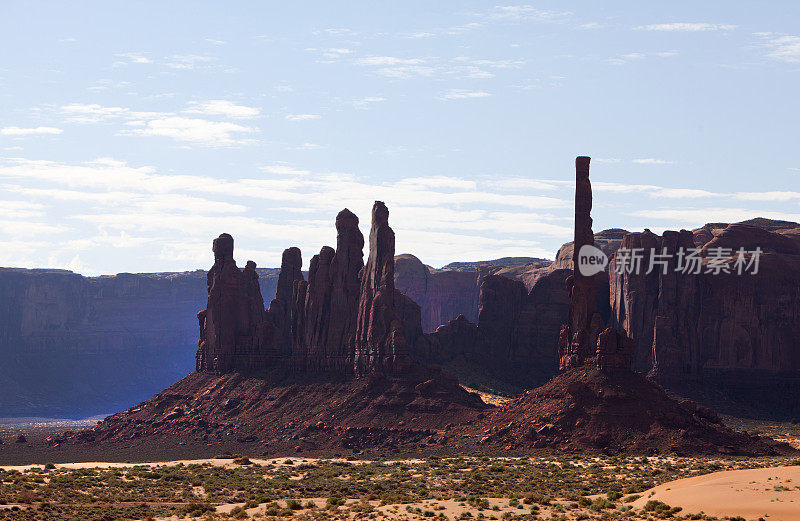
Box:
[558,157,634,371]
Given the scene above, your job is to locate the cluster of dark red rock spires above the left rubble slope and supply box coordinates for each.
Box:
[197,201,421,375]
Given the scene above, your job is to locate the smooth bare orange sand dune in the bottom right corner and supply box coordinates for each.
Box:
[632,466,800,521]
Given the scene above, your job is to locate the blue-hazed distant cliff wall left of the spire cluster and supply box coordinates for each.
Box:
[0,269,205,416]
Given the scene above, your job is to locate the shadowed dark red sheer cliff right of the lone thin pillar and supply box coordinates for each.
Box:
[611,224,800,378]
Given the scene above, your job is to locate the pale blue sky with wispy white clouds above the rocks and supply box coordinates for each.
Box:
[0,0,800,275]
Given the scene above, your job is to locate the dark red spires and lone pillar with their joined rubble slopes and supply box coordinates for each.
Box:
[56,157,792,454]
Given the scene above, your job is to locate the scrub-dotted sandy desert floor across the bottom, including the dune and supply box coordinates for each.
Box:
[0,455,800,521]
